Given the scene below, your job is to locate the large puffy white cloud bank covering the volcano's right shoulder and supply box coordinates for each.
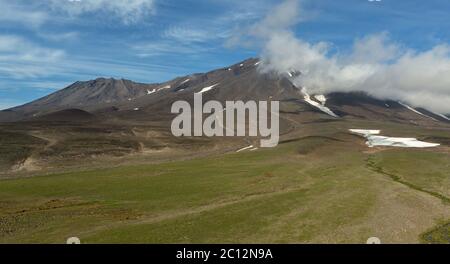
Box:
[239,0,450,113]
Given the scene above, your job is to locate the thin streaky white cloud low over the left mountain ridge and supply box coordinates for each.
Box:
[0,34,188,85]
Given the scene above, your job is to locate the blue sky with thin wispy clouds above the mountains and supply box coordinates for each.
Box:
[0,0,450,109]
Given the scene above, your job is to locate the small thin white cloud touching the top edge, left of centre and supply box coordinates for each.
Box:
[48,0,155,24]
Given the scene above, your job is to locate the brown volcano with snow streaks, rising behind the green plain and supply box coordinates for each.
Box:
[0,58,450,171]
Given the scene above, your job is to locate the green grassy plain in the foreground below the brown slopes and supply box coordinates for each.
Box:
[0,119,450,243]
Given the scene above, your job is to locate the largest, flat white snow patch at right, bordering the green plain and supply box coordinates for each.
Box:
[349,129,440,148]
